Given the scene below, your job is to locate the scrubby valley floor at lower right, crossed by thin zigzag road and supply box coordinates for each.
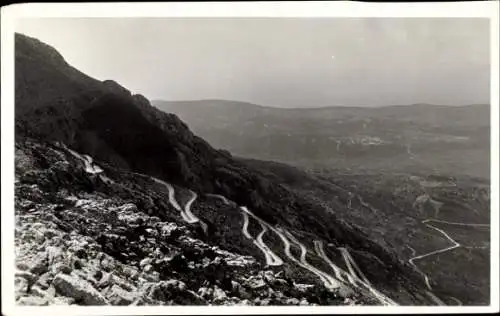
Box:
[242,159,491,305]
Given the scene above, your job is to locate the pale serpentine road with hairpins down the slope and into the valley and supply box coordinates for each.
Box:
[61,145,480,305]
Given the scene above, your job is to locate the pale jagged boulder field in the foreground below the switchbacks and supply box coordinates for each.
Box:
[15,142,372,305]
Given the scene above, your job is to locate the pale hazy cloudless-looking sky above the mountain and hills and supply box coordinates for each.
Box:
[17,18,490,107]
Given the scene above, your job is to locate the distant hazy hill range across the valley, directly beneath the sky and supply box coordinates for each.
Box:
[153,100,490,178]
